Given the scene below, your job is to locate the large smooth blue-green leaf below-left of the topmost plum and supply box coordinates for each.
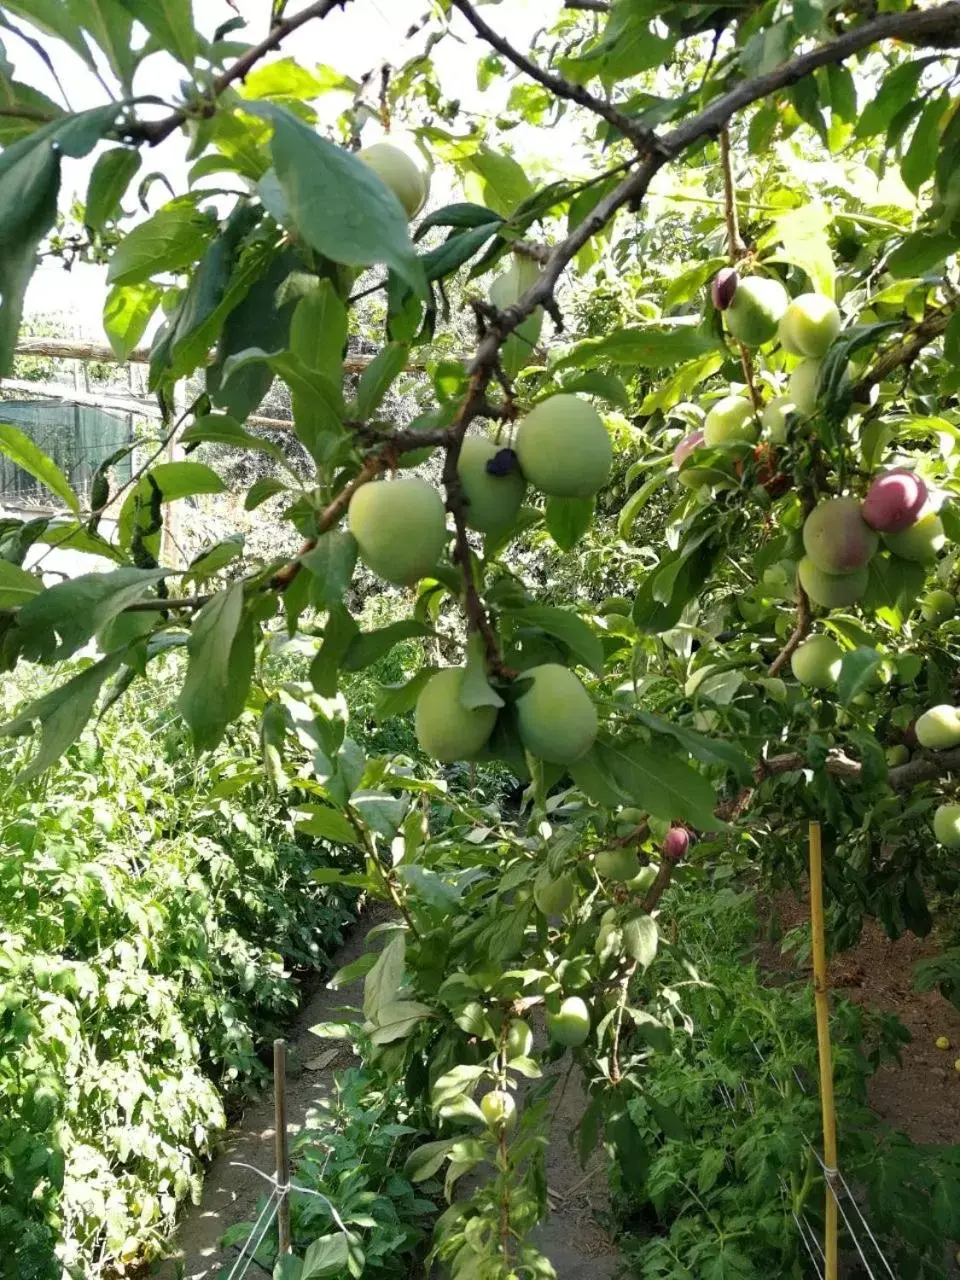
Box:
[250,102,426,296]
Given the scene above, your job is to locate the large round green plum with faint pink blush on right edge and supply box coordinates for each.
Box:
[513,394,613,498]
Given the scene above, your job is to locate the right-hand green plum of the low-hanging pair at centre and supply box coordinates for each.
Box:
[516,662,596,764]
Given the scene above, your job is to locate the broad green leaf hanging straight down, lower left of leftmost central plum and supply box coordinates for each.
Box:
[174,581,253,751]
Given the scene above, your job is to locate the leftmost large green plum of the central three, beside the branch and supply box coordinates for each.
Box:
[347,476,447,586]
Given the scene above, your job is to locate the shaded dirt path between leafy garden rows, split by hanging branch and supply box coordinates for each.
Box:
[150,913,620,1280]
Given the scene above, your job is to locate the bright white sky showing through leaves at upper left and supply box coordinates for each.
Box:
[18,0,583,339]
